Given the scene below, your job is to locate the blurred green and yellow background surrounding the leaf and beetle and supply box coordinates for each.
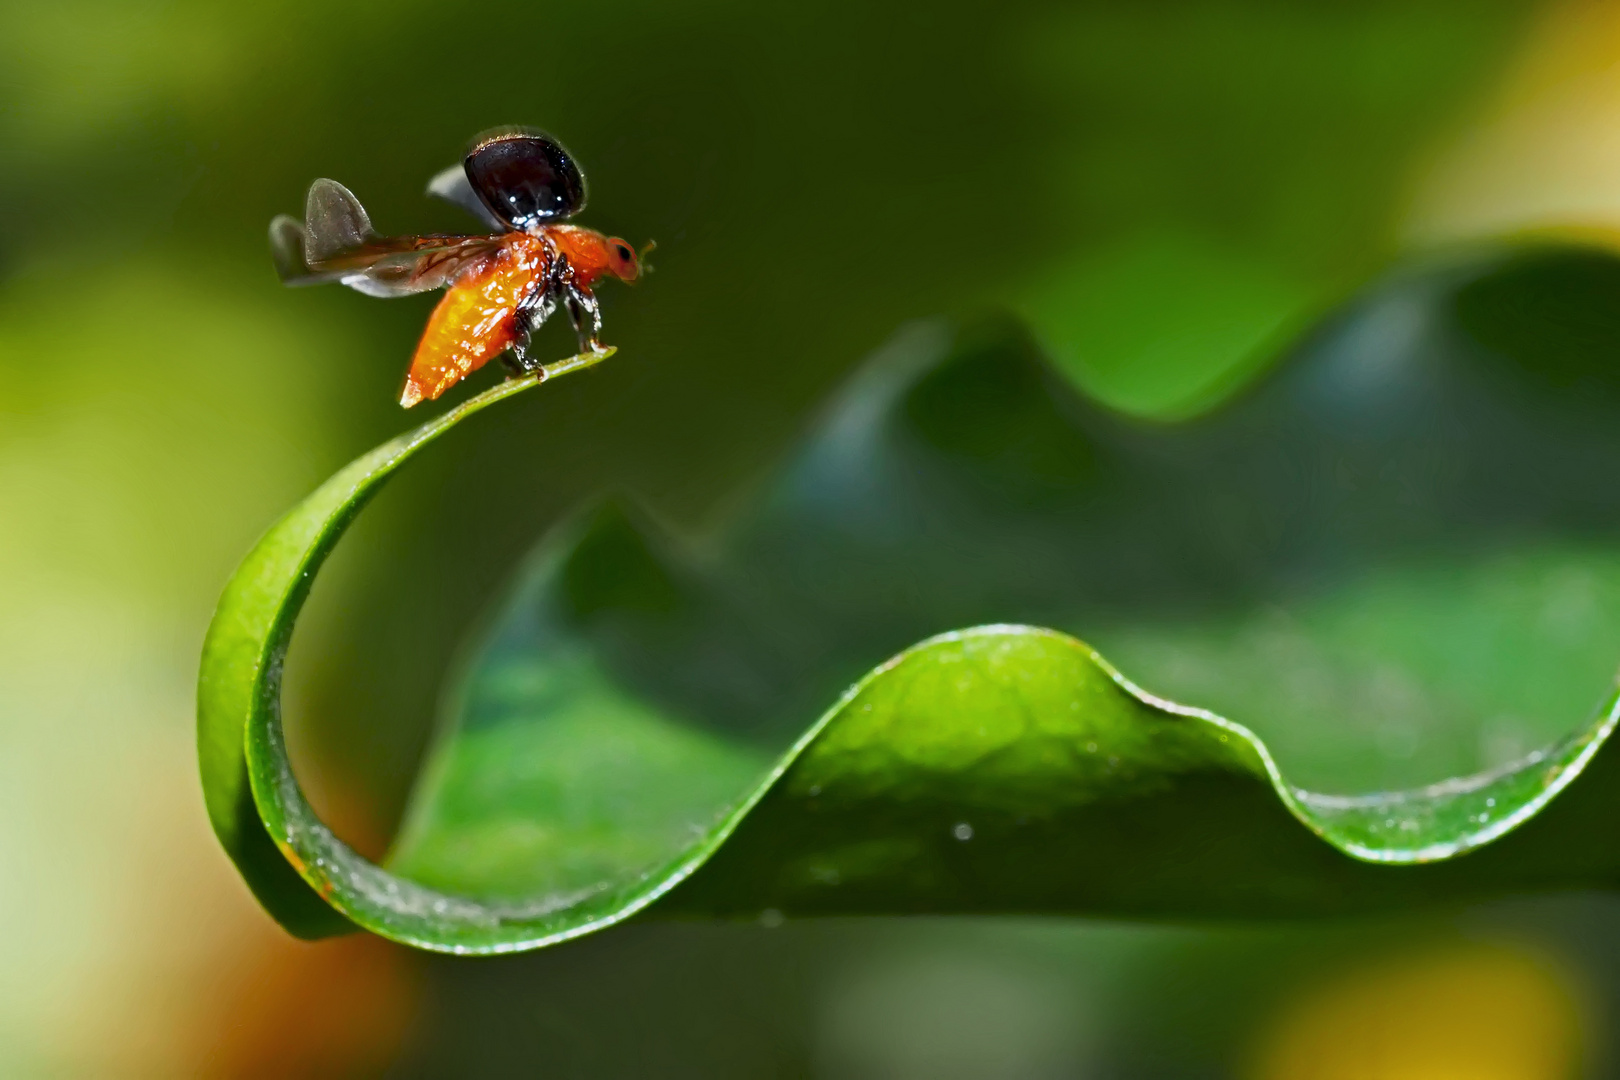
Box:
[9,0,1620,1077]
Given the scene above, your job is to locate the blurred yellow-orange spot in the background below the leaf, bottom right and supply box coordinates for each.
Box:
[1251,946,1580,1080]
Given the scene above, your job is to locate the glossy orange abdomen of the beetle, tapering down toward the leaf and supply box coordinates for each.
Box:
[400,233,551,408]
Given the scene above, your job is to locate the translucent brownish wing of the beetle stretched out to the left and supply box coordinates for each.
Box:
[271,180,501,296]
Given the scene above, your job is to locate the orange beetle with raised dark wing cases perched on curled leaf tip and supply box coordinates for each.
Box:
[271,128,642,408]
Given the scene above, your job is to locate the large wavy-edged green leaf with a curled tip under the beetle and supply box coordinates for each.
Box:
[201,251,1620,954]
